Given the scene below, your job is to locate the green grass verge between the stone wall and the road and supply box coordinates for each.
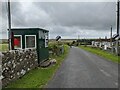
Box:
[6,45,69,88]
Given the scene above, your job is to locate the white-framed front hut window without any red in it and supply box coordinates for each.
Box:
[25,35,36,48]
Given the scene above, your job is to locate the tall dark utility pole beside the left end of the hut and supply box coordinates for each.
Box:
[8,0,12,50]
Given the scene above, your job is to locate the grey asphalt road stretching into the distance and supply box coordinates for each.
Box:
[45,47,118,88]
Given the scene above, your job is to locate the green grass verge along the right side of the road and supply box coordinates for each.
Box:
[79,46,120,63]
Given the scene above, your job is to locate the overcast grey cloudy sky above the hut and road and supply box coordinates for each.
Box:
[0,1,116,39]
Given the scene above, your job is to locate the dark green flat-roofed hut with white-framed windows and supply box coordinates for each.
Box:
[11,28,49,64]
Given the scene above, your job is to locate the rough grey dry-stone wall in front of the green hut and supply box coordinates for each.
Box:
[0,49,38,87]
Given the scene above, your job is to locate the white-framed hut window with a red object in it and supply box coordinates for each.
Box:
[14,35,22,49]
